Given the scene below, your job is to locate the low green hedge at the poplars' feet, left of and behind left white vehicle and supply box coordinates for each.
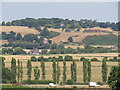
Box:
[21,80,53,84]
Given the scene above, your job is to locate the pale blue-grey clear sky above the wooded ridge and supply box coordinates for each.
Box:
[2,2,118,22]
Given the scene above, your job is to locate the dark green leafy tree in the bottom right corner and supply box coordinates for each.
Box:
[108,66,120,90]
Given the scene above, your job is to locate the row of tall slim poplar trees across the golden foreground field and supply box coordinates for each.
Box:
[1,57,114,84]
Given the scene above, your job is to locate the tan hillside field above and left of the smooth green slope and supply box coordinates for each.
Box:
[49,29,118,43]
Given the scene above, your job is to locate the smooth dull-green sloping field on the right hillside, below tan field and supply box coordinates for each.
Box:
[82,34,118,45]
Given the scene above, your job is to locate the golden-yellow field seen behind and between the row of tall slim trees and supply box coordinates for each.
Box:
[3,53,118,82]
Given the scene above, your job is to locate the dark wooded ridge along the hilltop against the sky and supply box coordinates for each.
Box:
[2,18,119,30]
